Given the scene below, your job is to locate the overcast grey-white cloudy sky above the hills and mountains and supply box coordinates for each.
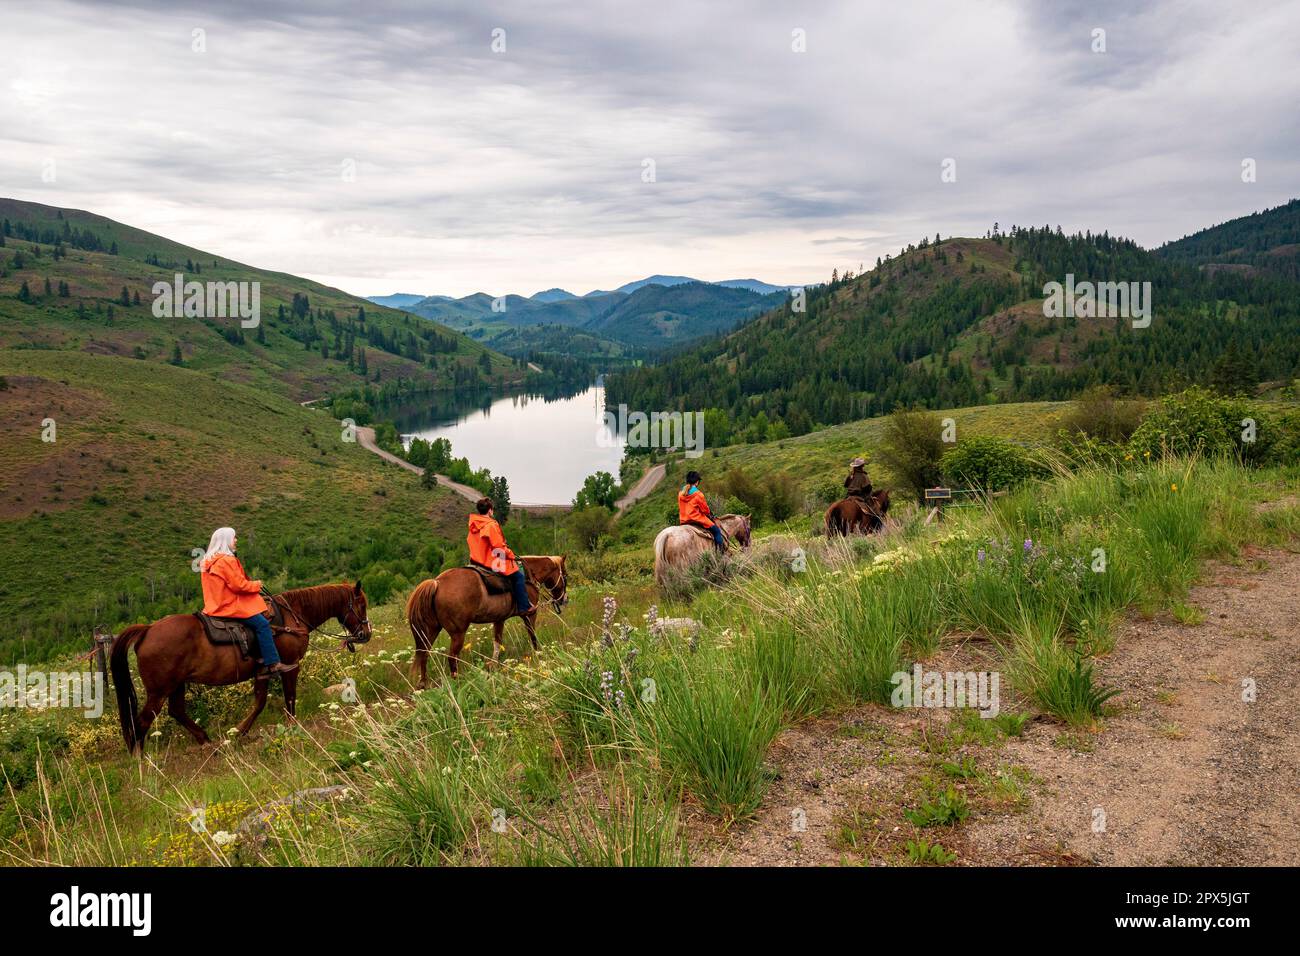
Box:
[0,0,1300,295]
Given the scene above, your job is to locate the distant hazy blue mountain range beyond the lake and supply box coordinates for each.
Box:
[371,276,787,355]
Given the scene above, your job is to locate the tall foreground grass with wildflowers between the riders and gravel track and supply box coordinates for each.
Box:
[0,442,1300,865]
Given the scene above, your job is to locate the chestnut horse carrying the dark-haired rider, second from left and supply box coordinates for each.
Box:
[407,554,568,688]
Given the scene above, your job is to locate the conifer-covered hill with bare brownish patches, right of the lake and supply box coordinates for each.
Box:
[607,224,1300,442]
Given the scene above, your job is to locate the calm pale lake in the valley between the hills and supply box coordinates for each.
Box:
[385,385,623,505]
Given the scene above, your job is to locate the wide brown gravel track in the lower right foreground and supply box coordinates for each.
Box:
[692,550,1300,866]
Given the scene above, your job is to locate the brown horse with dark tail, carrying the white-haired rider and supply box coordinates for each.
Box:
[109,581,371,753]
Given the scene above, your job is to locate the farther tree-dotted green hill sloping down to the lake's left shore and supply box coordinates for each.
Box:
[0,199,527,401]
